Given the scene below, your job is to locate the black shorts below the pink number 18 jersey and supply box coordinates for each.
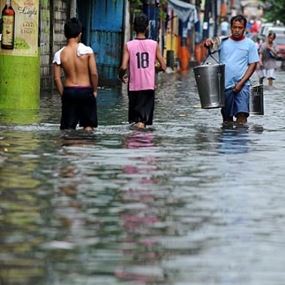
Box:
[128,90,155,125]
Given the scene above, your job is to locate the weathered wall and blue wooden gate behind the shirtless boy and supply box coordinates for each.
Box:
[39,0,128,90]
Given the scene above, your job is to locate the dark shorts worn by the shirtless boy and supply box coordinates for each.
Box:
[60,87,98,130]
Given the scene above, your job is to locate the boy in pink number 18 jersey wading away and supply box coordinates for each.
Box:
[119,14,166,128]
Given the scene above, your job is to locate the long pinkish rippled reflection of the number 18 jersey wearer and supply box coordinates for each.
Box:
[115,130,165,284]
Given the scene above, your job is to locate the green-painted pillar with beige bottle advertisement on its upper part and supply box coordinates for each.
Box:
[0,0,40,109]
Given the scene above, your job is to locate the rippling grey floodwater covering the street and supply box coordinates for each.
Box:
[0,71,285,285]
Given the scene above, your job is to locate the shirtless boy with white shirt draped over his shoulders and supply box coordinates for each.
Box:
[53,18,98,131]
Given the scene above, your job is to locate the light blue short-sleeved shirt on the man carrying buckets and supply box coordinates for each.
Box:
[220,38,259,89]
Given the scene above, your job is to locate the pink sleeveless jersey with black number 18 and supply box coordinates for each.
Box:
[127,39,157,91]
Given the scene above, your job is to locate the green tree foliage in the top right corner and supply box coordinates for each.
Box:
[262,0,285,24]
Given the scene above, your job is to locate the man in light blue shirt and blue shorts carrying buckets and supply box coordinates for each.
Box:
[204,15,259,125]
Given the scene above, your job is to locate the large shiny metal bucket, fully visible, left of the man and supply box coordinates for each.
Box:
[194,64,225,109]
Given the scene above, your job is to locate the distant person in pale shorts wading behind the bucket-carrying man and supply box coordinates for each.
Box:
[259,31,277,86]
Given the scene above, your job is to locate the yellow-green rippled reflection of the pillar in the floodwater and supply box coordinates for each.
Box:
[0,130,44,284]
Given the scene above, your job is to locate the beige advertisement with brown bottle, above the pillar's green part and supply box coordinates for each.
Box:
[0,0,39,56]
